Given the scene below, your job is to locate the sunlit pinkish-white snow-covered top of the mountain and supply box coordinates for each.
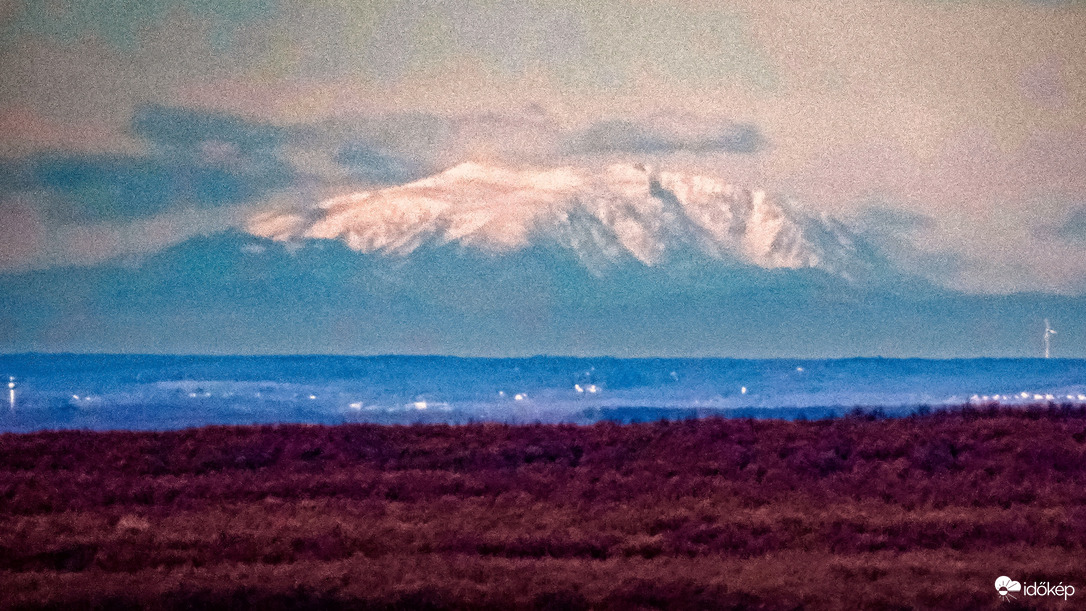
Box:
[247,163,879,279]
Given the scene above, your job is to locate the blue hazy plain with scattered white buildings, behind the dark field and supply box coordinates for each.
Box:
[0,354,1086,431]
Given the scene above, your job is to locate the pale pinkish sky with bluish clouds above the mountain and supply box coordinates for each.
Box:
[0,0,1086,352]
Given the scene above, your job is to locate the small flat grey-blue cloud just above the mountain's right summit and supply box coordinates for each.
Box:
[567,119,766,154]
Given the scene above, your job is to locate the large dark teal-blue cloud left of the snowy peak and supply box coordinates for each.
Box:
[0,105,294,225]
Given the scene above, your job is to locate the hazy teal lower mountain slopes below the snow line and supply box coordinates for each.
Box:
[0,227,1086,357]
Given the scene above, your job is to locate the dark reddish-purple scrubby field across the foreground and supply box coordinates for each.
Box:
[0,408,1086,609]
